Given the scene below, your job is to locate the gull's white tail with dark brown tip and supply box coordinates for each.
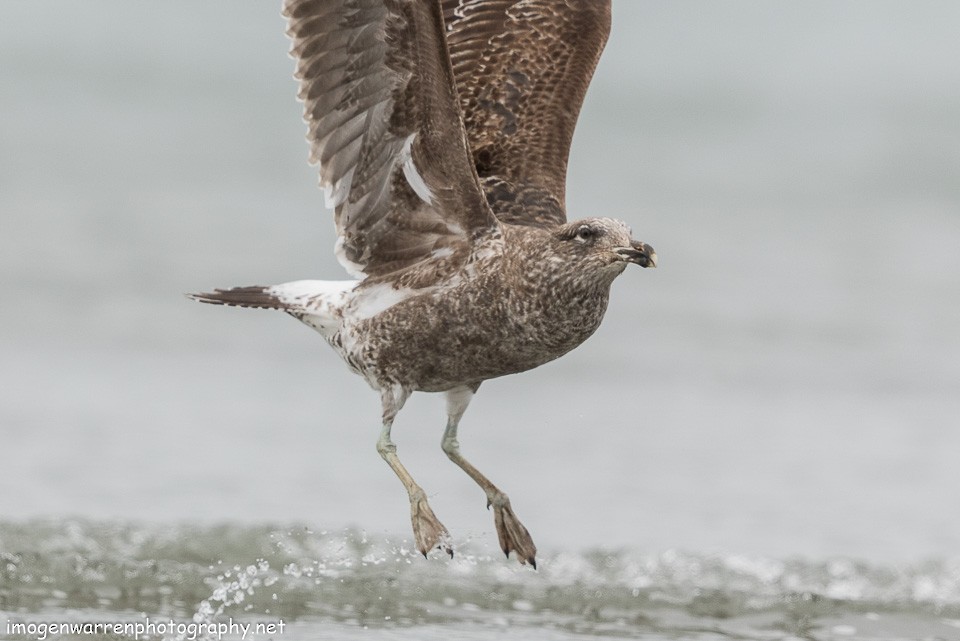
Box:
[187,280,357,338]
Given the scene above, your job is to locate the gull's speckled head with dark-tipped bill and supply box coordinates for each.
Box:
[554,218,657,277]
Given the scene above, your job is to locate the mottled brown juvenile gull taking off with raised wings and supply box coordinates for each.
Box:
[193,0,657,567]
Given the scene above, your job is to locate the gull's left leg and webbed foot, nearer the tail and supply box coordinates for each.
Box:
[377,387,453,556]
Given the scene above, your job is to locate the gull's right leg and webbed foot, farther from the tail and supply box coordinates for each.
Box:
[442,387,537,569]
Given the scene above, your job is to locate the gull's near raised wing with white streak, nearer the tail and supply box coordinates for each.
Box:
[283,0,498,277]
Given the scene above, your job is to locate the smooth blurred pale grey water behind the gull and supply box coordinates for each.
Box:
[0,0,960,638]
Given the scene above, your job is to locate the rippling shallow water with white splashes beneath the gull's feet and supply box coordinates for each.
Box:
[0,521,960,640]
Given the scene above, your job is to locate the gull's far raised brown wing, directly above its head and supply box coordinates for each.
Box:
[442,0,610,225]
